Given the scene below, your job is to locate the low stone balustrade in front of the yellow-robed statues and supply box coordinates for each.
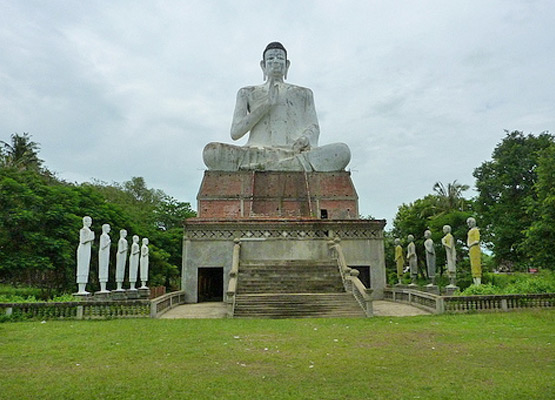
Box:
[384,287,555,314]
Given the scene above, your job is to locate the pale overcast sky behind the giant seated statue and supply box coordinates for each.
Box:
[0,0,555,228]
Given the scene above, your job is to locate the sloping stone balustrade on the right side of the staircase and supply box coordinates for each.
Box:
[328,237,374,317]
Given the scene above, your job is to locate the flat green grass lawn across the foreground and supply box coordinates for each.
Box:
[0,310,555,400]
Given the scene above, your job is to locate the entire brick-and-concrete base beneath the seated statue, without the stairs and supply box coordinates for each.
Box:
[181,171,386,303]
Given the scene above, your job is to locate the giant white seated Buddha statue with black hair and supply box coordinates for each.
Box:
[203,42,351,171]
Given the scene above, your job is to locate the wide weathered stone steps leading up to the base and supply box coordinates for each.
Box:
[233,260,366,318]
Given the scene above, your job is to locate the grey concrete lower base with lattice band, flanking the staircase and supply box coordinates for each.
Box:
[182,218,386,303]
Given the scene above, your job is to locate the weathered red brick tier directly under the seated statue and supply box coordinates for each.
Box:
[197,171,359,219]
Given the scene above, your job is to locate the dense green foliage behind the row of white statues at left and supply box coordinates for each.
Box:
[0,134,195,292]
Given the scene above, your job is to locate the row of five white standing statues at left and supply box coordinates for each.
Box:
[77,216,149,295]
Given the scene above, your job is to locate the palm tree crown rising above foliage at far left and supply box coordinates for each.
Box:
[0,133,43,171]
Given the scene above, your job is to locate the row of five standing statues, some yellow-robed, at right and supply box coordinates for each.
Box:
[395,217,482,288]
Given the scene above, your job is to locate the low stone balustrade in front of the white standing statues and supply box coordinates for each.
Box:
[0,300,150,320]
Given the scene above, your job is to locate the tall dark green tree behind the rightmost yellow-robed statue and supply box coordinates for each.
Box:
[474,131,554,269]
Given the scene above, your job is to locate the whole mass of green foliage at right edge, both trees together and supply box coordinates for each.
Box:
[474,131,555,270]
